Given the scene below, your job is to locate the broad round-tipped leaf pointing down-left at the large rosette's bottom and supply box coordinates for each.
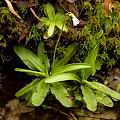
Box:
[32,79,49,106]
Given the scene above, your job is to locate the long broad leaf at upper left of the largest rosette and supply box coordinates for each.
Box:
[14,46,45,72]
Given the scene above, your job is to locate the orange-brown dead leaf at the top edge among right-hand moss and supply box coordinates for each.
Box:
[103,0,113,14]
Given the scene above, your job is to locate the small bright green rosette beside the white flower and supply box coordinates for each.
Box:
[41,3,68,39]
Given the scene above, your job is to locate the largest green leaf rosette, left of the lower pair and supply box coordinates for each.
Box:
[14,42,91,107]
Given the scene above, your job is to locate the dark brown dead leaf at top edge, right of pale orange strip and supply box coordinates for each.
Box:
[14,0,37,8]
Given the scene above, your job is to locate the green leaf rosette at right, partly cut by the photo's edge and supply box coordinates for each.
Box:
[75,45,120,111]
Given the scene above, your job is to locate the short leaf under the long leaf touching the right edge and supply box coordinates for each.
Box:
[94,90,113,107]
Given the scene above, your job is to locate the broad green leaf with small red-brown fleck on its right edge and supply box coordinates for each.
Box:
[50,82,73,107]
